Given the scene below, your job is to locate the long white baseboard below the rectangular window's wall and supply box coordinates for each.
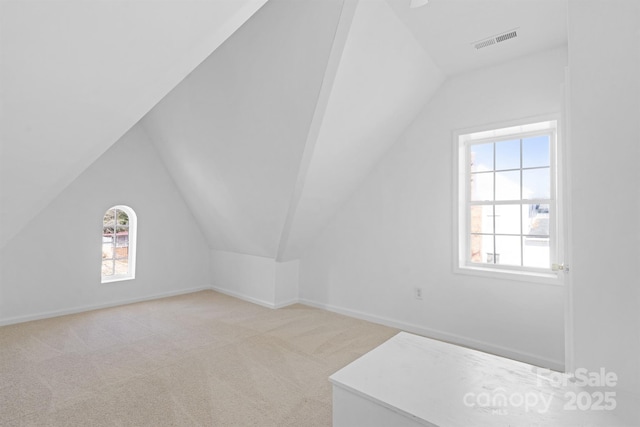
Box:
[299,298,564,372]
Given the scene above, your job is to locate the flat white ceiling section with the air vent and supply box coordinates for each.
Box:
[386,0,567,75]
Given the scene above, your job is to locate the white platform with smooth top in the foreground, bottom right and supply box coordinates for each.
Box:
[330,332,640,427]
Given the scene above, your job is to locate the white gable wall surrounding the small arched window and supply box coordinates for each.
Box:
[0,126,209,323]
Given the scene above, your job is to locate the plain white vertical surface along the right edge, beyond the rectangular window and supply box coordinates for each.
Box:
[569,0,640,402]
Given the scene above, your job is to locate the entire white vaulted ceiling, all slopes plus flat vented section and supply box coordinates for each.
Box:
[1,0,566,260]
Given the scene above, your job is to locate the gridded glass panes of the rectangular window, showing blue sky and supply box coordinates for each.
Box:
[467,129,552,268]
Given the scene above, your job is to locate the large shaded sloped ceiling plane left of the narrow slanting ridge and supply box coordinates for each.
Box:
[142,0,343,258]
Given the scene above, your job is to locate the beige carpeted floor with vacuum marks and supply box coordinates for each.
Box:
[0,291,398,427]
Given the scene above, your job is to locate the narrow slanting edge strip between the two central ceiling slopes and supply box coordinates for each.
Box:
[276,0,359,262]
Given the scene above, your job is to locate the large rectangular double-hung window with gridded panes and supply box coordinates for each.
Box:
[456,120,560,279]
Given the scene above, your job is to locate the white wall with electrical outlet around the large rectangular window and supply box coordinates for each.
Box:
[300,48,567,367]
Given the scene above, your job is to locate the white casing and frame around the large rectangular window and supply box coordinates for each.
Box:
[453,114,564,285]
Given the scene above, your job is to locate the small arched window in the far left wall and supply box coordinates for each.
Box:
[102,206,137,283]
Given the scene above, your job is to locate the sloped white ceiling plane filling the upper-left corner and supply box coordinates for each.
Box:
[0,0,266,246]
